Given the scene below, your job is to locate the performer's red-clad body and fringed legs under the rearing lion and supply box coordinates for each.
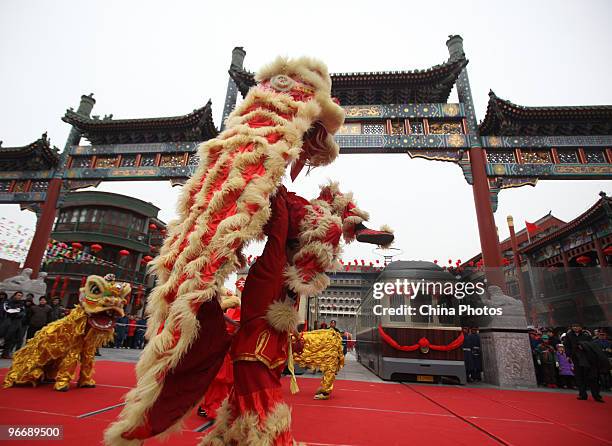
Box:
[203,186,302,445]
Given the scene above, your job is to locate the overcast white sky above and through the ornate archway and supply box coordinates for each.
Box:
[0,0,612,260]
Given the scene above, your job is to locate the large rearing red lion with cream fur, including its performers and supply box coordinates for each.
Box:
[105,58,393,446]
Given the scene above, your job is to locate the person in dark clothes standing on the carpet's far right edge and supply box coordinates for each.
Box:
[564,323,603,403]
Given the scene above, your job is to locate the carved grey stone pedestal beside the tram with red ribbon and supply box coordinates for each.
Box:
[480,328,537,388]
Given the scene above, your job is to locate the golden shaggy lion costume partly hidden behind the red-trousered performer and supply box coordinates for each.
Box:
[293,329,344,400]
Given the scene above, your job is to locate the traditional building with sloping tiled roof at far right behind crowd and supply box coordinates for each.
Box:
[464,192,612,327]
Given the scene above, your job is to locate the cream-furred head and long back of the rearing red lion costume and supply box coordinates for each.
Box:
[105,58,344,446]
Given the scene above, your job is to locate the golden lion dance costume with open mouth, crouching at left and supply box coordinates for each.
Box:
[4,274,131,392]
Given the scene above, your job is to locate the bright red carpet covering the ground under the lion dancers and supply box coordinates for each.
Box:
[0,361,612,446]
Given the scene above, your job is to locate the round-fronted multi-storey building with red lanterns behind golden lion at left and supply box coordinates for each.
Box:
[43,191,166,310]
